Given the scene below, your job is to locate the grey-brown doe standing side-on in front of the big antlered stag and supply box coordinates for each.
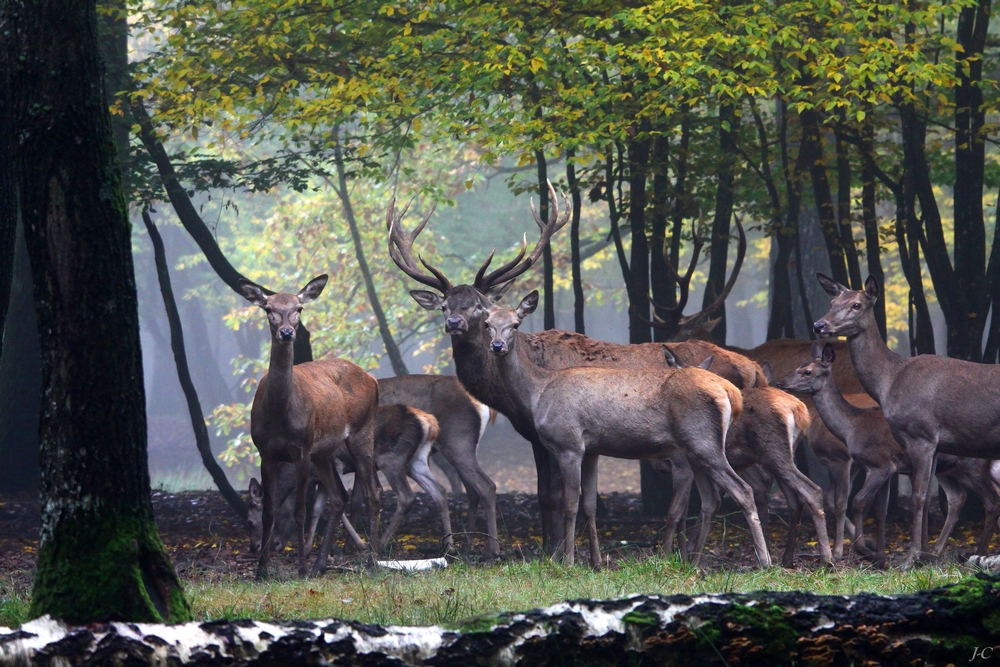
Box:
[484,291,771,567]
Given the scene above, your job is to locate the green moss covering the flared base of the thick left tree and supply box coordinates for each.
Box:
[30,511,192,623]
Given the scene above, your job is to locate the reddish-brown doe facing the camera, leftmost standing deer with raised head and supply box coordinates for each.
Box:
[240,275,380,578]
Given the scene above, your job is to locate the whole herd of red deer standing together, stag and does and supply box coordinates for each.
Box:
[241,185,1000,577]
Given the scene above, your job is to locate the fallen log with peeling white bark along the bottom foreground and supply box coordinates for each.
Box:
[0,574,1000,667]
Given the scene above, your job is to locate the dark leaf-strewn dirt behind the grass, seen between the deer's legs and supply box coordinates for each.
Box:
[0,480,981,591]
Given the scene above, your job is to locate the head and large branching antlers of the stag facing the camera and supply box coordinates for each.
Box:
[386,183,570,336]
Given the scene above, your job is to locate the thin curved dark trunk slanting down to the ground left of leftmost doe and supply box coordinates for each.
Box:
[142,209,247,521]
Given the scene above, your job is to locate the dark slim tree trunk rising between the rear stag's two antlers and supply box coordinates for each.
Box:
[702,104,737,345]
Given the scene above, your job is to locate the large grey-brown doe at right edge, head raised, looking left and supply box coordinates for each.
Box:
[813,274,1000,564]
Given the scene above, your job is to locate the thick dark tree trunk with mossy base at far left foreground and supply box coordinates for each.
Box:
[0,0,191,623]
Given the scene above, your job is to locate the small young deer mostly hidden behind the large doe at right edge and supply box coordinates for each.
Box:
[777,341,1000,564]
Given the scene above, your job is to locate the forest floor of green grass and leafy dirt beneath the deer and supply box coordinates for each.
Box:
[0,491,980,627]
